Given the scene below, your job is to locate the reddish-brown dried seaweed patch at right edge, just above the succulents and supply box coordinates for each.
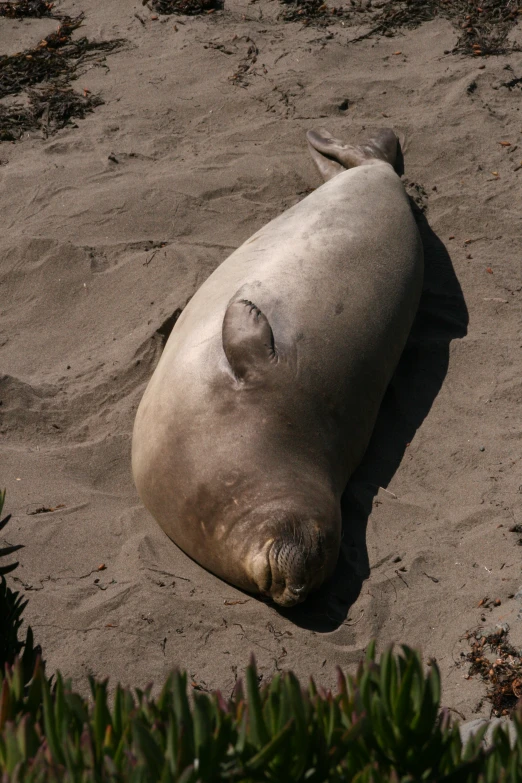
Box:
[465,626,522,717]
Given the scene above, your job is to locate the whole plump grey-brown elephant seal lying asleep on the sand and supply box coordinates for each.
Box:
[132,130,423,606]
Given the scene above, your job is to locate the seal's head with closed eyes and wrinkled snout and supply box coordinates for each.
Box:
[249,514,340,607]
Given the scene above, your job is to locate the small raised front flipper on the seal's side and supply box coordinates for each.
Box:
[223,299,277,380]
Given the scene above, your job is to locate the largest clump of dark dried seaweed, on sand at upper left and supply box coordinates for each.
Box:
[0,14,123,141]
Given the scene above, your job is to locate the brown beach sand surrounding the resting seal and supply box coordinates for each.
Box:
[0,0,522,718]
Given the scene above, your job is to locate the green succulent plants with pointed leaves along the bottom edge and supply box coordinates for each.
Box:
[0,486,522,783]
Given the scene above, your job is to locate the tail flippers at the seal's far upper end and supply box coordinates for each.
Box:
[306,128,400,181]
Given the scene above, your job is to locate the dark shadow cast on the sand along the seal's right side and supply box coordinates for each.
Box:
[280,204,468,633]
